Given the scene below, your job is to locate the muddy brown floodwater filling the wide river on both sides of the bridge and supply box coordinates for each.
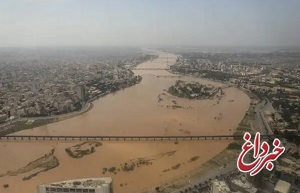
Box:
[0,52,250,193]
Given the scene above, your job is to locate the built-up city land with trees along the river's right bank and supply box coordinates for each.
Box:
[170,51,300,193]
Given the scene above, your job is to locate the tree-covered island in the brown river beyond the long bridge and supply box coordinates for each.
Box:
[168,80,223,100]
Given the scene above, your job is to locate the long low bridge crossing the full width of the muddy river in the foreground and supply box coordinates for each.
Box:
[0,135,276,141]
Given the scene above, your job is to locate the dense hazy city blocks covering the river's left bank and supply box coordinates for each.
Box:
[0,49,155,120]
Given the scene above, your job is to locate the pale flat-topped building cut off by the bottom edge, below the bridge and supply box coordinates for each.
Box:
[38,177,112,193]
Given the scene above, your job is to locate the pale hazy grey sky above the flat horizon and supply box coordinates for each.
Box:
[0,0,300,47]
